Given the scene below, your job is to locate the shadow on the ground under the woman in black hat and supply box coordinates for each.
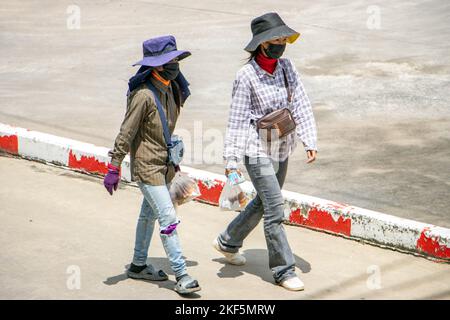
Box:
[212,249,311,283]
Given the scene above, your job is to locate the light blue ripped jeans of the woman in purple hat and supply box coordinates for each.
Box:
[133,182,187,277]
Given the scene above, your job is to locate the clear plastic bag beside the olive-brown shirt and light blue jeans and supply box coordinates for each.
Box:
[169,171,201,205]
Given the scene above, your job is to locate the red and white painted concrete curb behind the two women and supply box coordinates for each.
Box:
[0,123,450,262]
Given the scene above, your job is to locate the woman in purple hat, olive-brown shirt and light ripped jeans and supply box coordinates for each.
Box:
[104,36,200,294]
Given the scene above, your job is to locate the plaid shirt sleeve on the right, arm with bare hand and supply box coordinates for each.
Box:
[289,61,317,151]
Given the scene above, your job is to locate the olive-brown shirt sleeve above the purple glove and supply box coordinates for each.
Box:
[111,91,149,167]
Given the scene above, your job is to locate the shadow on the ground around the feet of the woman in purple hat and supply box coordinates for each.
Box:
[103,257,201,299]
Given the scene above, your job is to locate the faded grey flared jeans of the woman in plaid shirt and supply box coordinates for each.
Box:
[218,157,296,283]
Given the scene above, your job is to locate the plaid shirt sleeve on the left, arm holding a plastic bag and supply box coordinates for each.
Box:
[223,73,251,166]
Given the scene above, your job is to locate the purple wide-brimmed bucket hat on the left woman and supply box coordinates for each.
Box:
[133,36,191,67]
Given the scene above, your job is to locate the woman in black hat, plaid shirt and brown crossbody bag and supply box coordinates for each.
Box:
[213,13,317,291]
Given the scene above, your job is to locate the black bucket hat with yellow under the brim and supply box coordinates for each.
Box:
[245,12,300,52]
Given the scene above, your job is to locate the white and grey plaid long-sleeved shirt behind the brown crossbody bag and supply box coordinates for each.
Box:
[223,59,317,163]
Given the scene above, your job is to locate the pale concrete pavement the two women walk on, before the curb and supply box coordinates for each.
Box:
[0,157,450,299]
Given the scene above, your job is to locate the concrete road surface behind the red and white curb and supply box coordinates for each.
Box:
[0,0,450,227]
